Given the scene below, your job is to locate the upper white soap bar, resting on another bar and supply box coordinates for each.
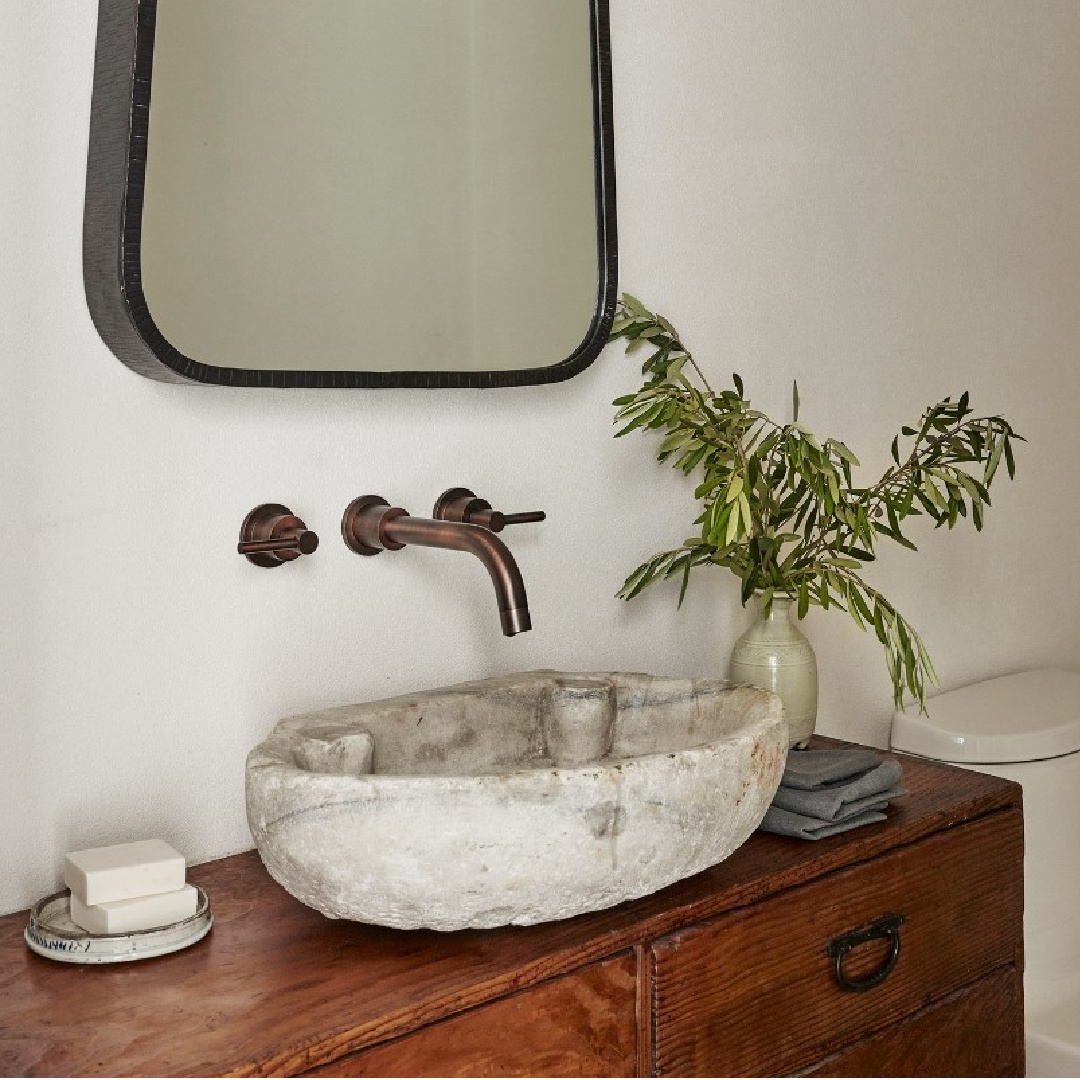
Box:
[64,840,185,904]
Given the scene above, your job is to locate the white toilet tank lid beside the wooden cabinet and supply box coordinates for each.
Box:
[892,667,1080,765]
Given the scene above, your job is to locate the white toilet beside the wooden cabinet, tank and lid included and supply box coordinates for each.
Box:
[892,669,1080,1077]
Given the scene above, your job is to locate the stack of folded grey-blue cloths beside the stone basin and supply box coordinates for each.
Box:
[760,747,906,840]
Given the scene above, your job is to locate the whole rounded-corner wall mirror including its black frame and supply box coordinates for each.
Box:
[84,0,616,387]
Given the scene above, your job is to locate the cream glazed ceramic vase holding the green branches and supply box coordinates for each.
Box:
[731,596,818,750]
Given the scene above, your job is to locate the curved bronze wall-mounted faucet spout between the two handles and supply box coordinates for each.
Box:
[341,495,532,637]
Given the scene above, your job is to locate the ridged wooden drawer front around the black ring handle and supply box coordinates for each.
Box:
[651,810,1024,1076]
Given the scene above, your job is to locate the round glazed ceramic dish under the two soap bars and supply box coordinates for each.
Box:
[23,886,214,963]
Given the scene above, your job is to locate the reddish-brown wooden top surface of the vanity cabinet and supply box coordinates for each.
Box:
[0,740,1021,1076]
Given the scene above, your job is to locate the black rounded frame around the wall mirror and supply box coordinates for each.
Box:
[83,0,618,388]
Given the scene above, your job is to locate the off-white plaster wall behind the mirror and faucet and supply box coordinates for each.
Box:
[0,0,1080,910]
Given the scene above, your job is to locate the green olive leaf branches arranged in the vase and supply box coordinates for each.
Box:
[609,294,1022,708]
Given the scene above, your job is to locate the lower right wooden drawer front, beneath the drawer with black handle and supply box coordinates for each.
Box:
[802,967,1024,1077]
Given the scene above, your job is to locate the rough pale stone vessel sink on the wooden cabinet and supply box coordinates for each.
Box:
[247,671,787,930]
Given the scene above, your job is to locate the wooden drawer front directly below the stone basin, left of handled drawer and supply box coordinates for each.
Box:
[305,953,637,1077]
